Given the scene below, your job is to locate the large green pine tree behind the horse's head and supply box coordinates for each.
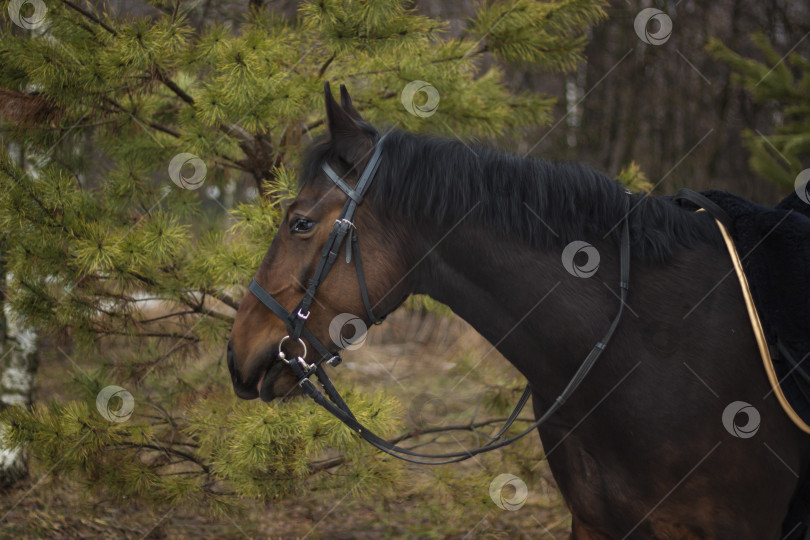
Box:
[0,0,604,524]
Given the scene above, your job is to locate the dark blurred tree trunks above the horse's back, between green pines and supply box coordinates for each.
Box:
[269,0,810,200]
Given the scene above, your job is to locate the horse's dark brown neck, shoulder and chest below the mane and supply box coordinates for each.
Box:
[416,221,808,539]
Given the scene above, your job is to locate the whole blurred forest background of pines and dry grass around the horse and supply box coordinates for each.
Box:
[0,0,810,538]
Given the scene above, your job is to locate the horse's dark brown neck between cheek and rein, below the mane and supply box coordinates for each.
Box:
[415,219,619,386]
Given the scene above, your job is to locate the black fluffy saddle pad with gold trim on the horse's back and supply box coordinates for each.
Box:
[702,191,810,424]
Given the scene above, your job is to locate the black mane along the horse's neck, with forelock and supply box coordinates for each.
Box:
[301,130,720,261]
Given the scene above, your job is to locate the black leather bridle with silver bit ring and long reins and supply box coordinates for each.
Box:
[248,136,630,465]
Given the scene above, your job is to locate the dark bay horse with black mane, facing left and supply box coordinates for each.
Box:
[227,86,810,540]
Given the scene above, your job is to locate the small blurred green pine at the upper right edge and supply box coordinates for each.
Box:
[707,33,810,187]
